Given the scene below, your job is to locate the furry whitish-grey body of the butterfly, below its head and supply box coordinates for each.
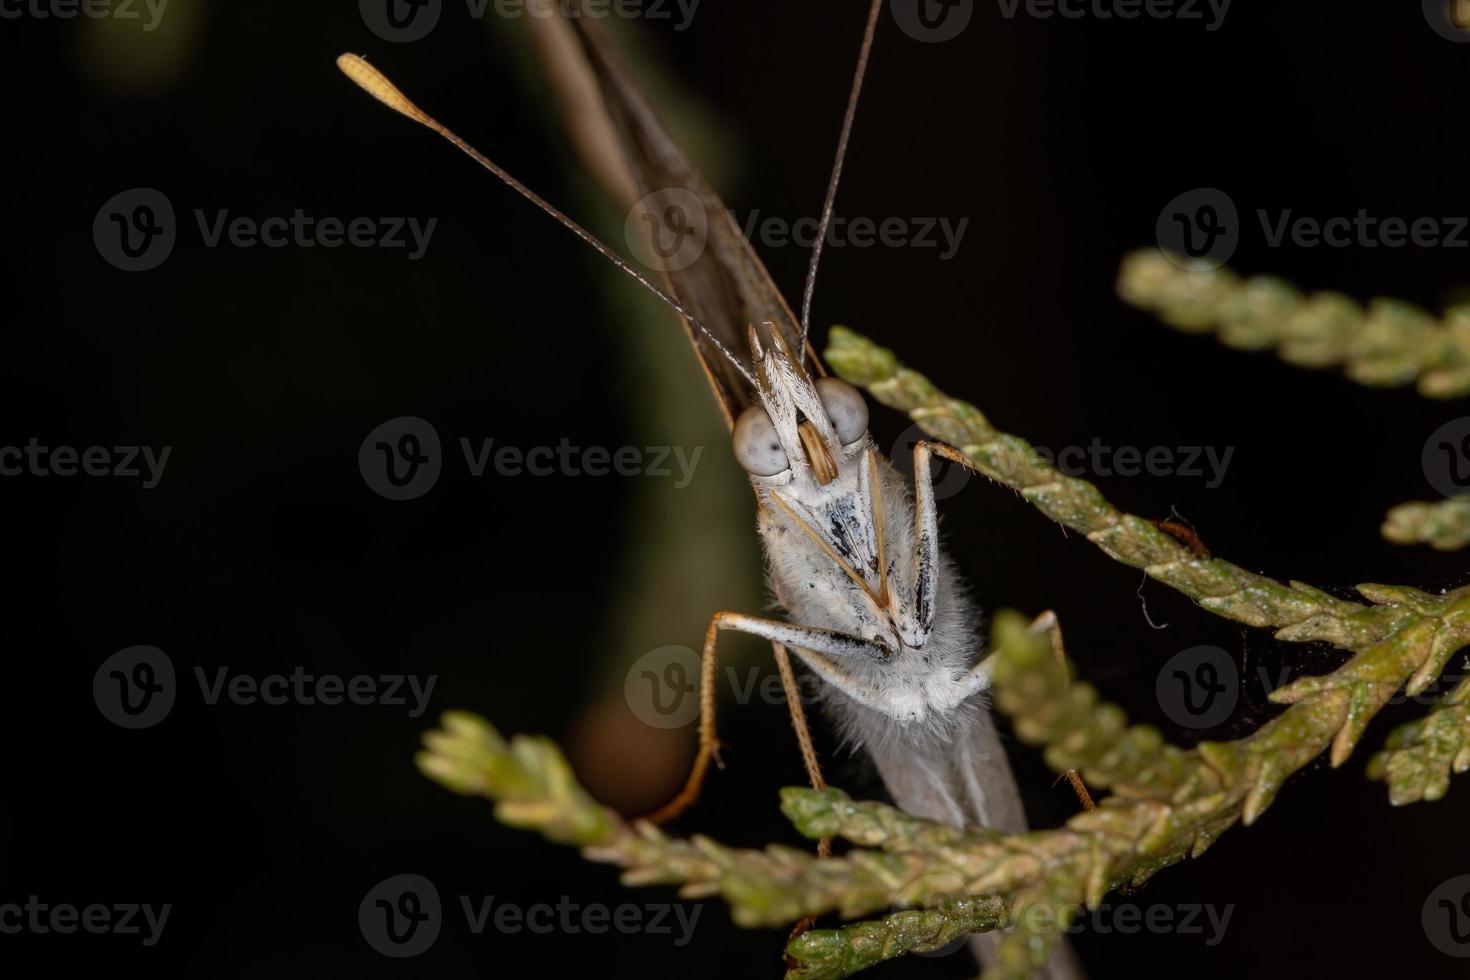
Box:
[757,438,1026,833]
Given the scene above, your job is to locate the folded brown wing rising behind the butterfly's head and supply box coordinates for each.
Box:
[528,6,820,422]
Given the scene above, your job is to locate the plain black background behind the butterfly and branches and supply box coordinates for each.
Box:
[0,0,1470,977]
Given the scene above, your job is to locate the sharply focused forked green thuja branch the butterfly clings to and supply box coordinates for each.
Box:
[419,320,1470,980]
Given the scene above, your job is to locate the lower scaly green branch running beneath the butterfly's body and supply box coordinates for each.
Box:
[419,611,1466,980]
